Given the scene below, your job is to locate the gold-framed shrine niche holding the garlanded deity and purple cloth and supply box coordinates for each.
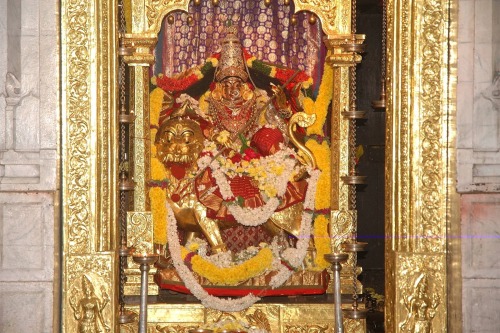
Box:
[116,1,364,326]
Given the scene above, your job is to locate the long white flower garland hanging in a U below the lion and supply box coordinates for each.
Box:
[166,170,319,312]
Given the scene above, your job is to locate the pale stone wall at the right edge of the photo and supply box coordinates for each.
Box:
[457,0,500,333]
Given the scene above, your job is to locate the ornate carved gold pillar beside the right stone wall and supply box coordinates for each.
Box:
[386,0,461,332]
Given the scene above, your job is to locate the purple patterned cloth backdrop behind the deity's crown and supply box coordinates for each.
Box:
[153,0,325,91]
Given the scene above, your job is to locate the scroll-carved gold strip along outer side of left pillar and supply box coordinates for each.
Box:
[62,1,92,253]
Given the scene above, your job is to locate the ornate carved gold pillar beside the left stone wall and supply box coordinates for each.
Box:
[61,0,118,332]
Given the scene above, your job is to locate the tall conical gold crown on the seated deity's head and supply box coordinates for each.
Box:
[215,26,248,82]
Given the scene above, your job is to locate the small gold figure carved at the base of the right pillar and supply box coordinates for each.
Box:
[401,273,440,333]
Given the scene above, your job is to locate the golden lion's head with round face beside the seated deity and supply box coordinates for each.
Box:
[155,118,204,166]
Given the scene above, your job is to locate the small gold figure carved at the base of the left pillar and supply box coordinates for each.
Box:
[69,274,110,333]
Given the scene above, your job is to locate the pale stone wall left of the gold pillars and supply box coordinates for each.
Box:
[0,0,59,333]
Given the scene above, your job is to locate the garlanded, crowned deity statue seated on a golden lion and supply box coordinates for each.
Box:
[150,27,328,306]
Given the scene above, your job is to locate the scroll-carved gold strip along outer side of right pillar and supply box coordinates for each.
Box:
[416,0,446,252]
